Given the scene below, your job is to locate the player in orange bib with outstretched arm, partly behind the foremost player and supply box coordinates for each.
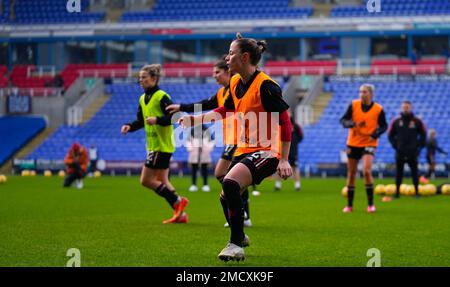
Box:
[167,55,253,227]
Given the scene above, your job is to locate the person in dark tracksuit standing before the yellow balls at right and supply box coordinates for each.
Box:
[388,101,427,198]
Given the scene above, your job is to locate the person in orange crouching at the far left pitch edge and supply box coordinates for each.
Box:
[63,143,89,189]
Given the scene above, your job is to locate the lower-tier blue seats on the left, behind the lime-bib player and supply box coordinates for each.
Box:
[28,83,221,161]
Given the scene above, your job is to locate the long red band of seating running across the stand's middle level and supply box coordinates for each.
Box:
[0,58,449,96]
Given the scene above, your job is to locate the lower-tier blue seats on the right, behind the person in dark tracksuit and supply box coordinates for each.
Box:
[299,77,450,170]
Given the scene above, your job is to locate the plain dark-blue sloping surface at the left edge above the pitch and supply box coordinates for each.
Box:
[0,116,46,165]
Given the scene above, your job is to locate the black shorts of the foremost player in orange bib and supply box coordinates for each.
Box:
[228,151,280,184]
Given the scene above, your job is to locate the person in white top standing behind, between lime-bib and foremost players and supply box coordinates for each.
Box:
[186,125,214,192]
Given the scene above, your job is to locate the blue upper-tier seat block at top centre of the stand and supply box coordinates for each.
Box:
[121,0,313,22]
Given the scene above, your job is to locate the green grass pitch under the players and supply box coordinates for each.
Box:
[0,176,450,267]
